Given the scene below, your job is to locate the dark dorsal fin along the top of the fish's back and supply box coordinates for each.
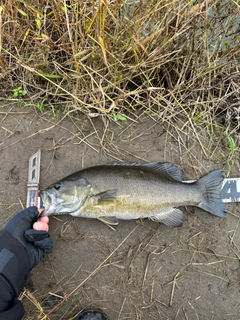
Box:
[108,161,182,182]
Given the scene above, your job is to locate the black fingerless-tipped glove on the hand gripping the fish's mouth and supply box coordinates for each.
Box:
[0,207,53,295]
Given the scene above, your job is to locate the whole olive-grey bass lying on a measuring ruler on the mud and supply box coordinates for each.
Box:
[39,162,226,227]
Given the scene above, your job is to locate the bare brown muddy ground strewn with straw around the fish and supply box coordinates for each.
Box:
[0,104,240,320]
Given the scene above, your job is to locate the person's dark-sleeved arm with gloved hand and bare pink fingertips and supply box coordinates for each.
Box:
[0,207,53,320]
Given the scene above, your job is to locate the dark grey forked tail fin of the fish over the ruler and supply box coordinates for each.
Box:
[196,170,226,218]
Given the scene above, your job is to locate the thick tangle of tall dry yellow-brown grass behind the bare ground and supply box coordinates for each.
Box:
[0,0,239,126]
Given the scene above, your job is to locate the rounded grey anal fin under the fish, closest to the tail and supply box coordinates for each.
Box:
[149,207,184,227]
